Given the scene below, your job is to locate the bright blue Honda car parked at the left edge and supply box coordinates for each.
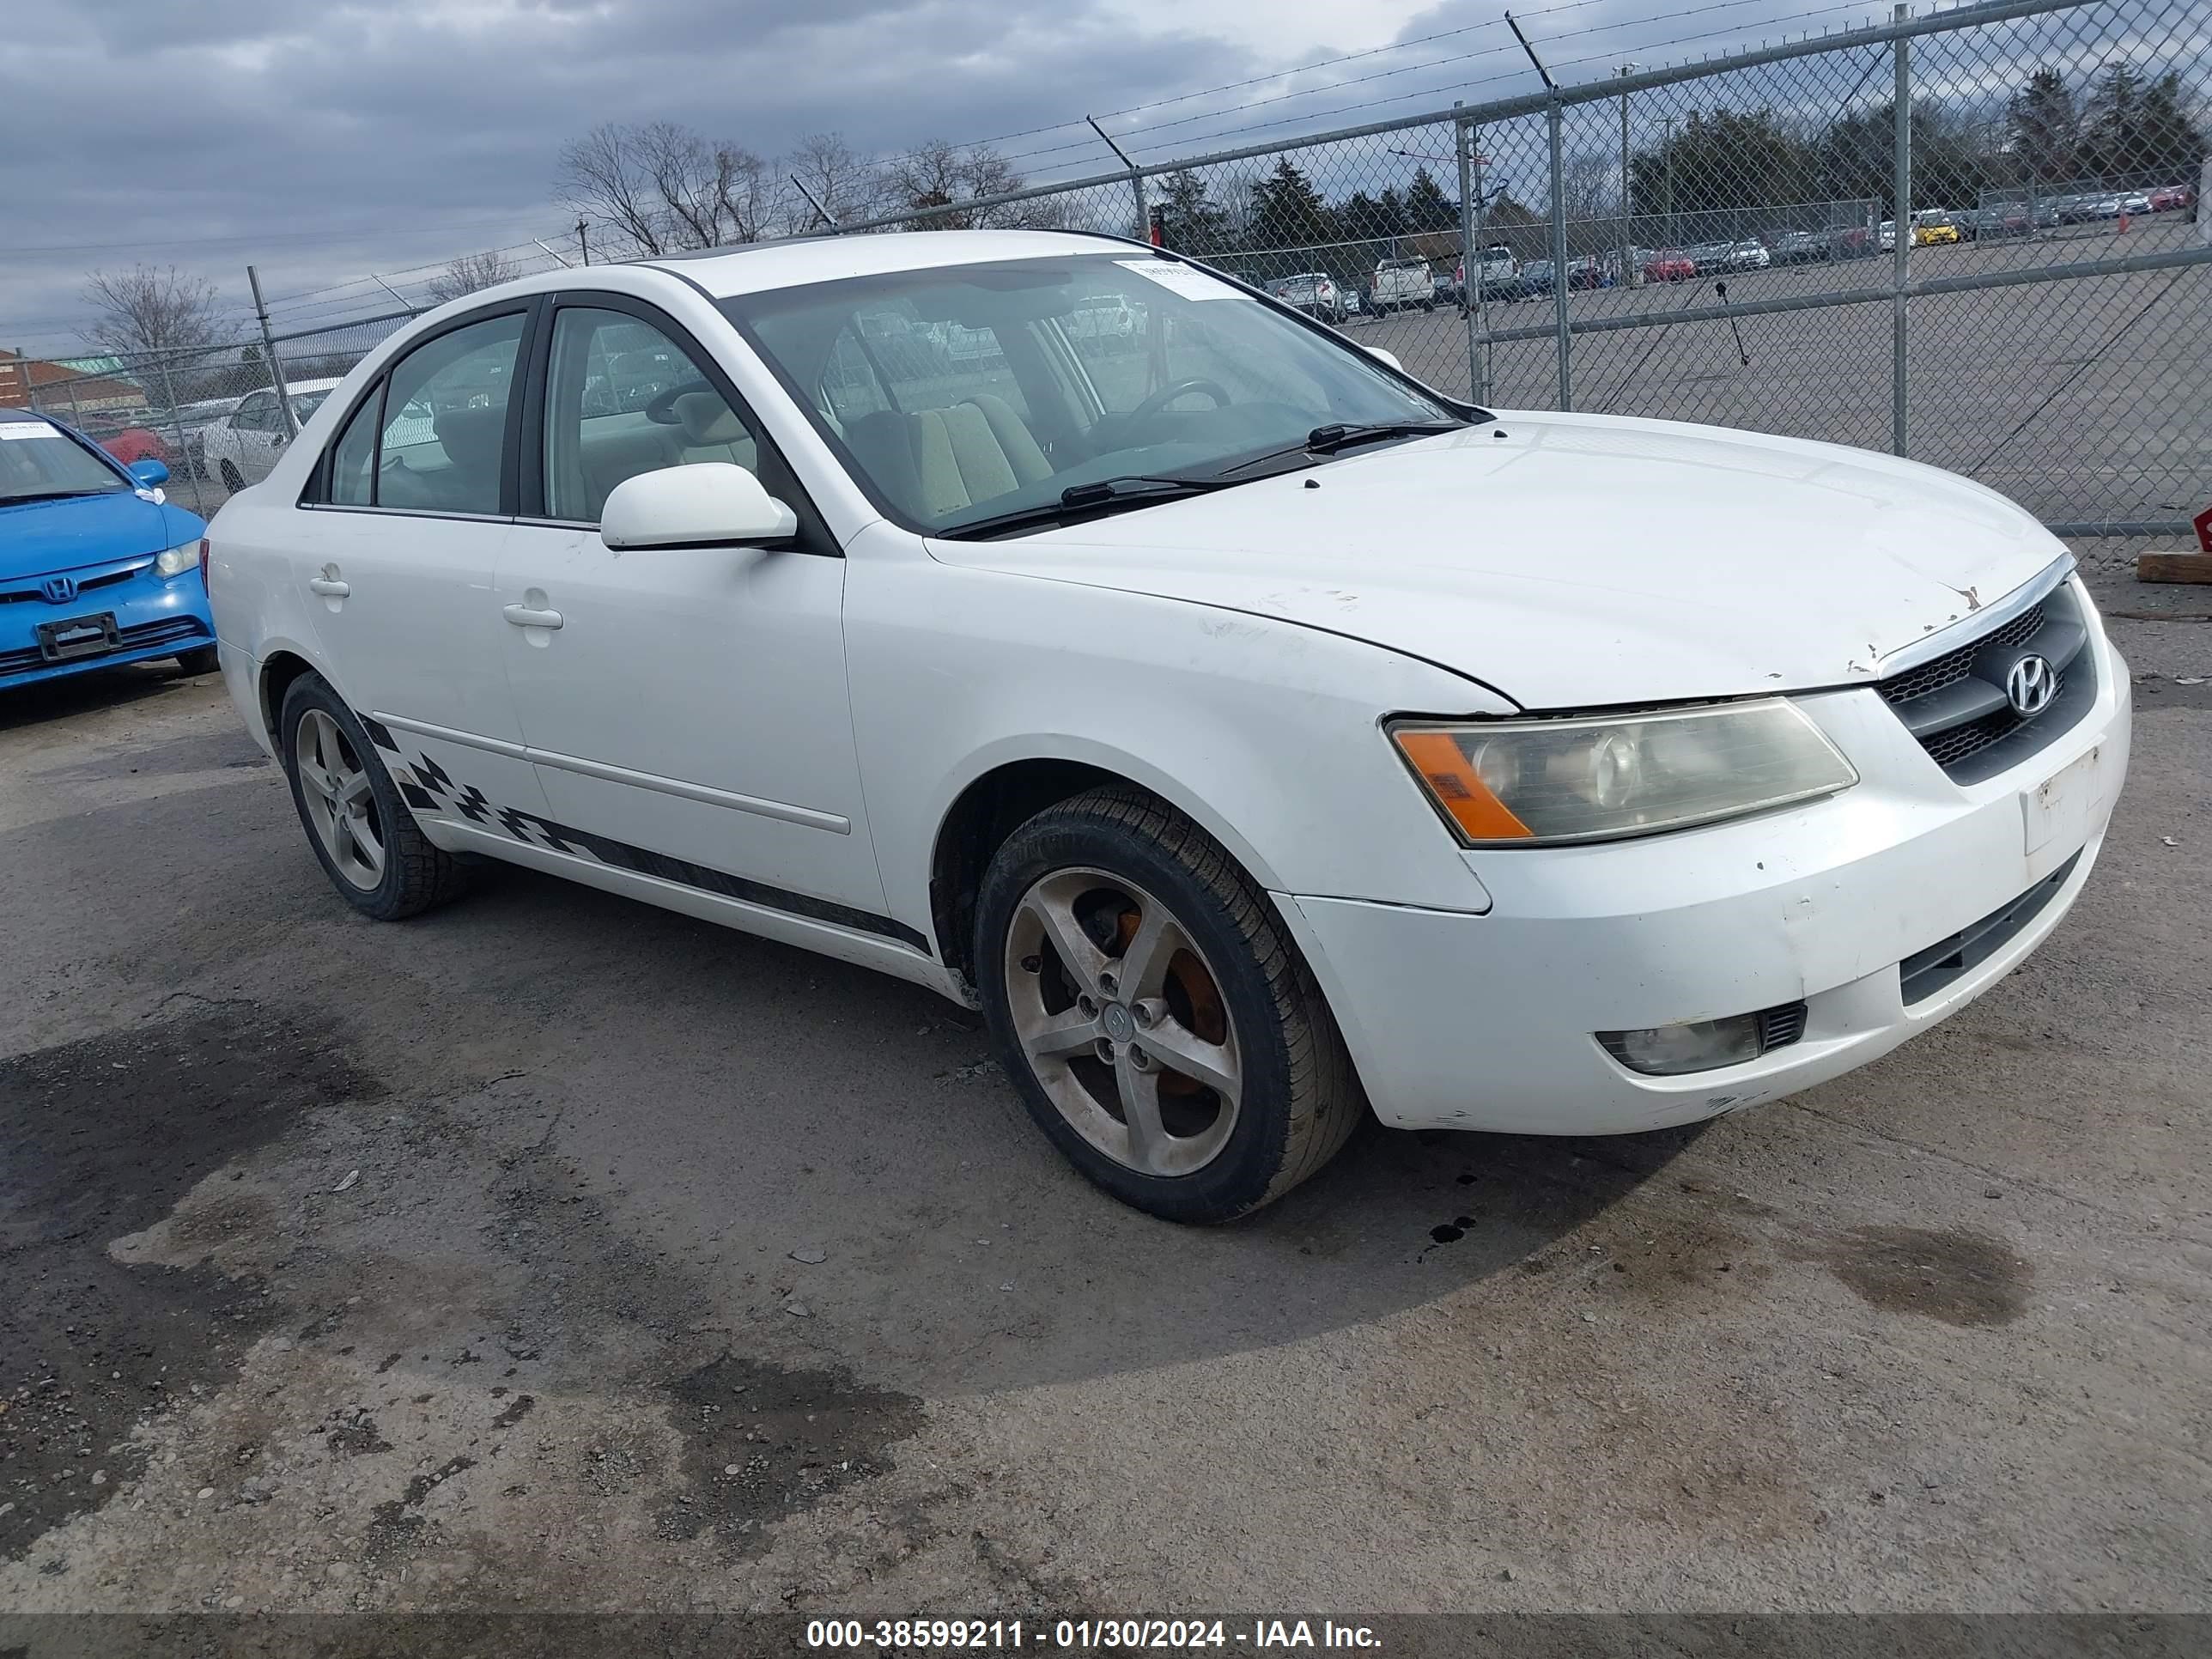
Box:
[0,410,216,690]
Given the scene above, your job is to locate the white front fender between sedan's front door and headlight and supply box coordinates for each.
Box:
[845,556,1509,946]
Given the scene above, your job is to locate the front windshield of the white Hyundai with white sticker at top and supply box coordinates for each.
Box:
[723,250,1458,533]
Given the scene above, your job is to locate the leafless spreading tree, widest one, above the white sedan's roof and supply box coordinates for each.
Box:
[557,122,779,254]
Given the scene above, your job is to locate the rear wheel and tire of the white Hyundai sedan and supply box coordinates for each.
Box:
[276,675,465,922]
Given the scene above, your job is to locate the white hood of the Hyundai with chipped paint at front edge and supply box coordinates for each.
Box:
[931,414,2066,708]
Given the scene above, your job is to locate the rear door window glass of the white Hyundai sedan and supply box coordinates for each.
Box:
[375,312,525,514]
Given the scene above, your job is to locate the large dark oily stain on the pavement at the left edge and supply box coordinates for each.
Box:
[0,1002,374,1559]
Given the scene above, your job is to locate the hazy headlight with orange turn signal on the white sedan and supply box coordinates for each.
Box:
[1389,699,1858,848]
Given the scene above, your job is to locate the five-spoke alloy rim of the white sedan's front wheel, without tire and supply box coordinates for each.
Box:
[1005,869,1243,1176]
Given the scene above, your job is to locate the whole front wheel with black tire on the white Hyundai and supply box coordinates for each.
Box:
[975,790,1363,1224]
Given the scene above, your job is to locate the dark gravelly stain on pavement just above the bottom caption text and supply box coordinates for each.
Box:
[659,1354,922,1553]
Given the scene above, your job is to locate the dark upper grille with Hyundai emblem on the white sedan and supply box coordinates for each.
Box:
[1875,584,2097,783]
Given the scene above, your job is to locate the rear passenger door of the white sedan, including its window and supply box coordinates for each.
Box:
[295,301,544,832]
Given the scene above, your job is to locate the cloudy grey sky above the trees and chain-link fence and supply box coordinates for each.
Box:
[0,0,1990,352]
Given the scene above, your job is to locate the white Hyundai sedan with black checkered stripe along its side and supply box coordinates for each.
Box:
[208,230,2128,1221]
